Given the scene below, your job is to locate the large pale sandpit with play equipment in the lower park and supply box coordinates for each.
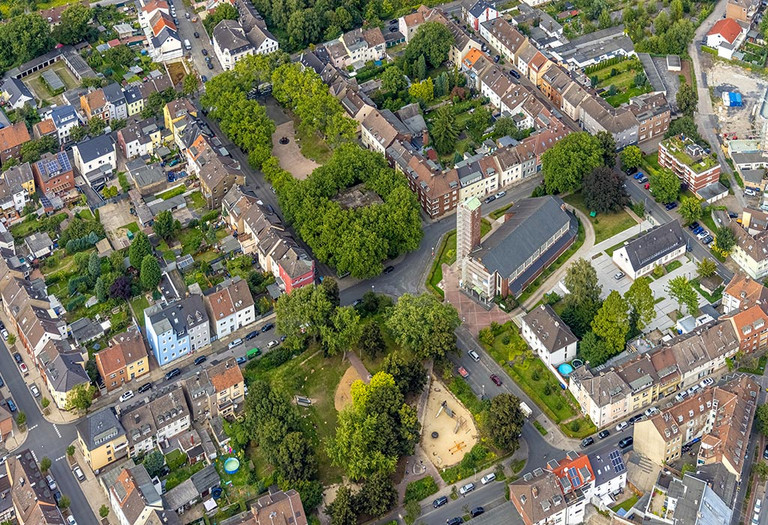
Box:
[421,377,478,468]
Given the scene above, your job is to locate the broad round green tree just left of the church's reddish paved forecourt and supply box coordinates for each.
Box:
[387,293,460,359]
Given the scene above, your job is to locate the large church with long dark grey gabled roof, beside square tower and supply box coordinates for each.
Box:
[457,196,578,301]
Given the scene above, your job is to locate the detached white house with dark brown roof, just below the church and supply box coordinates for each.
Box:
[520,304,578,368]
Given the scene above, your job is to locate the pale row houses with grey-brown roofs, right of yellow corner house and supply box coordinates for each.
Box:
[120,385,191,457]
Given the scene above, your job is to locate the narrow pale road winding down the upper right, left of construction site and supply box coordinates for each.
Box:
[688,0,746,208]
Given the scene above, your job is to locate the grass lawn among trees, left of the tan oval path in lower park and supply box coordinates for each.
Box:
[251,346,350,485]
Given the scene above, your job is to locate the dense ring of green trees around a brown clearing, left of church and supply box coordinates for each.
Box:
[263,144,422,278]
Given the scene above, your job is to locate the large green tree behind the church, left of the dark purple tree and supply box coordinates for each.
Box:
[541,131,603,193]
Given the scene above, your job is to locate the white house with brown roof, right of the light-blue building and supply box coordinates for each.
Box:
[204,277,256,339]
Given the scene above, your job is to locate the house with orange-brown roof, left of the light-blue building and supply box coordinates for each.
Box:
[93,326,149,392]
